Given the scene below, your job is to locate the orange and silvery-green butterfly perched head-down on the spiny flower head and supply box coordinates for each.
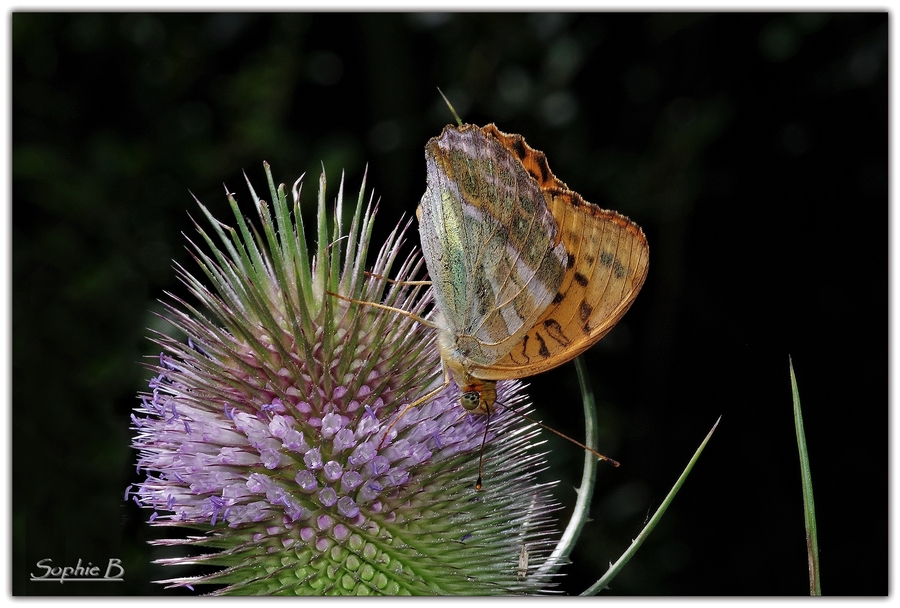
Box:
[416,124,649,414]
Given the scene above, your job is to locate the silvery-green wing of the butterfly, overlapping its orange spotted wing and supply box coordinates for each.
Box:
[417,125,568,366]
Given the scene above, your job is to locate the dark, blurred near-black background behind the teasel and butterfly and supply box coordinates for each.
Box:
[12,13,888,595]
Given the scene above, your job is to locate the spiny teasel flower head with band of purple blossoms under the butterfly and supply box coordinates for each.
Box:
[126,166,562,595]
